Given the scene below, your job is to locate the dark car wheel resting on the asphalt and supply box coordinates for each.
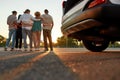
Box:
[83,40,109,52]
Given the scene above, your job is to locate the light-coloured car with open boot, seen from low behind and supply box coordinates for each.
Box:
[61,0,120,52]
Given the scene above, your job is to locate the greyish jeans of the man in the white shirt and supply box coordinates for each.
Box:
[22,28,32,48]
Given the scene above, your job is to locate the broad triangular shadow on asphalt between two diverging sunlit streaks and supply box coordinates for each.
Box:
[15,52,80,80]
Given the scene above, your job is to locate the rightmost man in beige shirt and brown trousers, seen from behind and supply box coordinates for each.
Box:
[41,9,54,51]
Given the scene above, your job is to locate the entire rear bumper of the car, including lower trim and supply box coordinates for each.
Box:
[61,5,120,35]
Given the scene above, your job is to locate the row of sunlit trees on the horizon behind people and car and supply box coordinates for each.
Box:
[0,35,120,48]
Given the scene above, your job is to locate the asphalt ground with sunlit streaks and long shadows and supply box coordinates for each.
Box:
[0,48,120,80]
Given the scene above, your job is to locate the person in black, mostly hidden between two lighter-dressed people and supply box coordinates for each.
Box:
[15,15,22,50]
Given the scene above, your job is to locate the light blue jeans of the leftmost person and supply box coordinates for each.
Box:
[5,29,16,48]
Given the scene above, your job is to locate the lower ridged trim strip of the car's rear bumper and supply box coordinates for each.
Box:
[63,19,102,36]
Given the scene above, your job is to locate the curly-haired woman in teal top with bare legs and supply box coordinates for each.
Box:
[31,11,41,51]
